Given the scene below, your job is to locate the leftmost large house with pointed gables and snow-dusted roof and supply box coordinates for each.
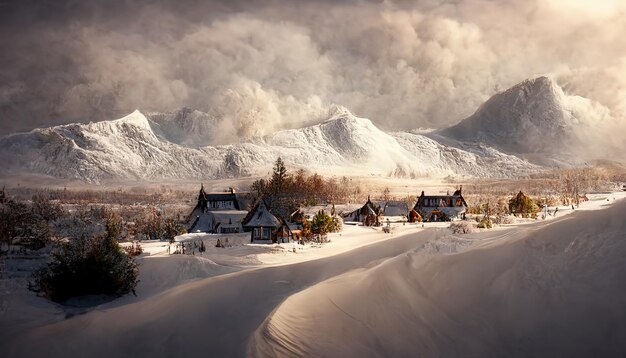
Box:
[187,185,248,233]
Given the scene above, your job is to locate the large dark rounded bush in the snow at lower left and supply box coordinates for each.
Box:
[31,237,139,302]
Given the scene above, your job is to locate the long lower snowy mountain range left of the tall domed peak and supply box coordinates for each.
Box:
[0,106,538,182]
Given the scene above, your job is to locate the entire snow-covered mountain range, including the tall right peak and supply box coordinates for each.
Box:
[0,77,610,182]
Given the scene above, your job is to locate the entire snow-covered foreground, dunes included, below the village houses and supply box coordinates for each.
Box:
[0,192,626,357]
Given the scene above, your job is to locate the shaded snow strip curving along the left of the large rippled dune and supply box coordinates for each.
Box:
[0,229,438,357]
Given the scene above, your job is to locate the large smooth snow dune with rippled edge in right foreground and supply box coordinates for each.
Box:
[249,201,626,357]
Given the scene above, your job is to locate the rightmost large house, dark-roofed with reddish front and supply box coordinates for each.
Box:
[413,186,467,221]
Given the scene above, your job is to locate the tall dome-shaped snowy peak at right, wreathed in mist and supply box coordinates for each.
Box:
[435,76,610,158]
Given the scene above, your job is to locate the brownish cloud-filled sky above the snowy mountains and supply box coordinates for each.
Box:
[0,0,626,138]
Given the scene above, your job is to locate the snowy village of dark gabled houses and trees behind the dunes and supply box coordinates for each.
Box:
[157,158,623,263]
